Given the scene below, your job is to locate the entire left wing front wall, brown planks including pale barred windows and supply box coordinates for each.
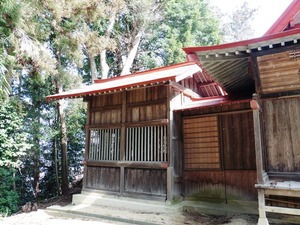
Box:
[84,85,169,196]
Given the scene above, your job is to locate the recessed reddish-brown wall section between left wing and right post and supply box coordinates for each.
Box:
[183,110,257,201]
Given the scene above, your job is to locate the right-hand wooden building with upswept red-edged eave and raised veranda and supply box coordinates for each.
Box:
[184,1,300,225]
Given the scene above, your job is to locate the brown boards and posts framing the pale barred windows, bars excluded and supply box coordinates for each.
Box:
[84,85,169,196]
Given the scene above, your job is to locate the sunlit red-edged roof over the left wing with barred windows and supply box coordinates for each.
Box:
[46,62,201,101]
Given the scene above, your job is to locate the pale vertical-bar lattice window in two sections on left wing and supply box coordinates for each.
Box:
[89,125,168,162]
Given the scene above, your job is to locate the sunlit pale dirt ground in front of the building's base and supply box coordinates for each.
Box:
[0,183,299,225]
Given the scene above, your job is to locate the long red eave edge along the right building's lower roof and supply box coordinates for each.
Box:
[183,28,300,54]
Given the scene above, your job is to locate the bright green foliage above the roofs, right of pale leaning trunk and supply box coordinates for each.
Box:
[136,0,221,68]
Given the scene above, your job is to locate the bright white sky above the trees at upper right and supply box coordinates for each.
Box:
[210,0,293,37]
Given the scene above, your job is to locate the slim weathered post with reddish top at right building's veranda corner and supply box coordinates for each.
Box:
[250,95,269,225]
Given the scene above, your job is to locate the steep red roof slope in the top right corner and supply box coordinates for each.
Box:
[264,0,300,36]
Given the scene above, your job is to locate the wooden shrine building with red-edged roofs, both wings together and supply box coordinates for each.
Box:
[47,0,300,225]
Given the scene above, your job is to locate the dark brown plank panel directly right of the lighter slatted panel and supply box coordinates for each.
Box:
[221,112,256,170]
